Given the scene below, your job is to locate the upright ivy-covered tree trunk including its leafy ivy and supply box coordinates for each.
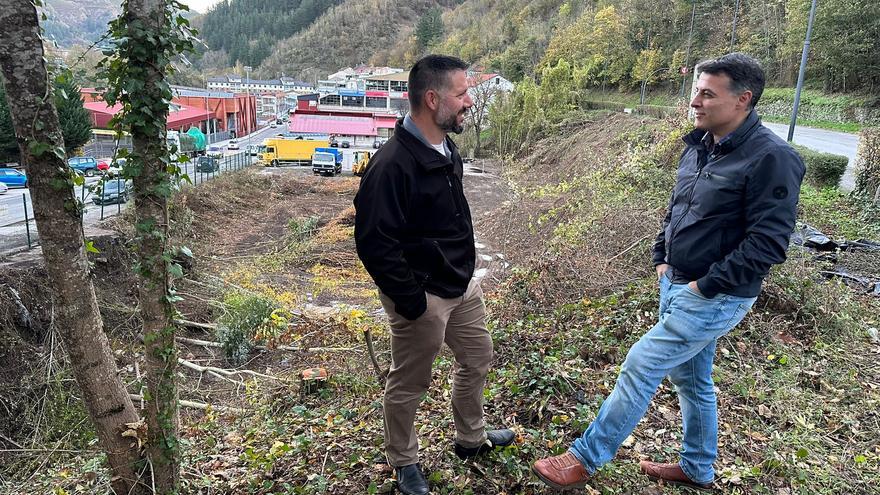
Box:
[101,0,195,494]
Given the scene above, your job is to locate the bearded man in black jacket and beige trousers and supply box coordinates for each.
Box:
[354,55,514,494]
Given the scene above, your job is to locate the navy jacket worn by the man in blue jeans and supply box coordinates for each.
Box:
[653,110,805,298]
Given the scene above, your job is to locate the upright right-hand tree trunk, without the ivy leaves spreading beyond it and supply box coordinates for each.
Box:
[121,0,181,494]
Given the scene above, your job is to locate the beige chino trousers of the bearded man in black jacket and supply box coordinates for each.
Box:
[379,279,492,467]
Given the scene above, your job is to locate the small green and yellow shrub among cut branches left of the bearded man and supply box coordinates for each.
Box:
[217,292,287,365]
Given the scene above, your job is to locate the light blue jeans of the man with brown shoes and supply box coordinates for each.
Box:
[570,275,756,483]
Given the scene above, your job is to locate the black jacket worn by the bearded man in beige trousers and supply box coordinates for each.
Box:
[354,120,476,320]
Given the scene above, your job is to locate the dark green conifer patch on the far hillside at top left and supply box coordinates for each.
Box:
[197,0,342,70]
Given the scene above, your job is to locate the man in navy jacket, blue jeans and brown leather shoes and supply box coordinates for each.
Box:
[533,53,804,488]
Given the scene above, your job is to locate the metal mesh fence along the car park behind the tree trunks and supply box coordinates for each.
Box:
[0,152,256,254]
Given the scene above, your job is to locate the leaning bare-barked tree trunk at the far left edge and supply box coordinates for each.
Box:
[0,0,147,494]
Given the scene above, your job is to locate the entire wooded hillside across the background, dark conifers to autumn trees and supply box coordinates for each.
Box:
[189,0,880,92]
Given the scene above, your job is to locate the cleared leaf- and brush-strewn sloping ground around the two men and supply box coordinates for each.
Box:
[0,112,880,495]
